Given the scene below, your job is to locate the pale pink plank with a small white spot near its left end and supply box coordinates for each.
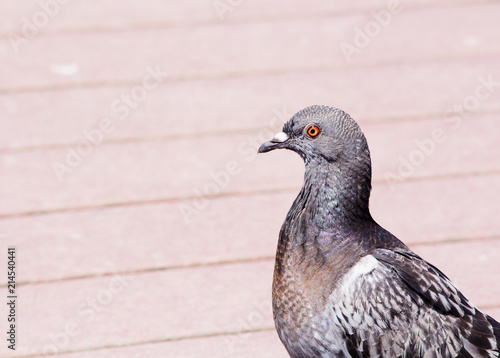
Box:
[0,3,500,93]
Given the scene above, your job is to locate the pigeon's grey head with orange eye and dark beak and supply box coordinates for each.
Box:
[259,106,370,165]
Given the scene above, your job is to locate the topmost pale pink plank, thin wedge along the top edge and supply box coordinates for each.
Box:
[0,0,480,34]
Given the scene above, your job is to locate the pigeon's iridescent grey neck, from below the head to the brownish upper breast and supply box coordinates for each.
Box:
[273,163,377,310]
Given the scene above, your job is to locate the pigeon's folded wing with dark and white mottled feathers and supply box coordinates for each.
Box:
[334,249,500,358]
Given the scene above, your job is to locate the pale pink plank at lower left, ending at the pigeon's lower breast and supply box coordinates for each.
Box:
[0,260,273,357]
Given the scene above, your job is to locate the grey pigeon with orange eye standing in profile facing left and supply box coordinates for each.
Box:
[259,106,500,358]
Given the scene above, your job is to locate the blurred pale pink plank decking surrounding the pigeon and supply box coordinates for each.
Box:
[0,0,500,358]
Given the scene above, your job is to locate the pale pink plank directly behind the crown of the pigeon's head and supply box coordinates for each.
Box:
[0,58,500,150]
